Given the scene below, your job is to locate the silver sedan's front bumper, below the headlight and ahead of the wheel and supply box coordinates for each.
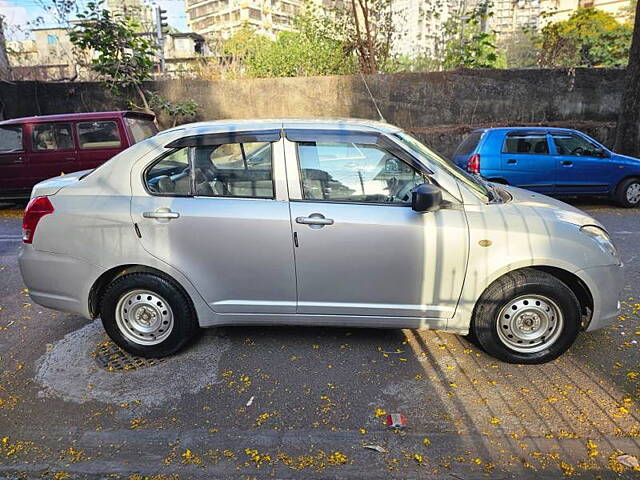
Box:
[576,265,624,332]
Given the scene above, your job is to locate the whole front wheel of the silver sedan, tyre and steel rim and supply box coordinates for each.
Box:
[471,269,581,364]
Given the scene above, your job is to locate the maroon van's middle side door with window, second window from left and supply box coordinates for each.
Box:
[27,122,81,186]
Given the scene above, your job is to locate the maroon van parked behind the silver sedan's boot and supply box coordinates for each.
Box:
[0,111,158,199]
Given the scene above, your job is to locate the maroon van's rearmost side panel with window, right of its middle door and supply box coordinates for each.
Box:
[75,119,125,170]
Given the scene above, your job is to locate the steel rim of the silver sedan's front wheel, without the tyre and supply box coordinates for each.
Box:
[496,295,564,353]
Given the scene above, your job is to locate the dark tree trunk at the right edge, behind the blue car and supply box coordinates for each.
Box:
[615,0,640,156]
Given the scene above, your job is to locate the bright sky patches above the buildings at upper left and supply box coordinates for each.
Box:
[0,0,187,40]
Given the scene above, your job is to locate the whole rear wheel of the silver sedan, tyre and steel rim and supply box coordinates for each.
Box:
[101,273,199,358]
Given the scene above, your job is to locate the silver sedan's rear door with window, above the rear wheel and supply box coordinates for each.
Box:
[131,130,296,314]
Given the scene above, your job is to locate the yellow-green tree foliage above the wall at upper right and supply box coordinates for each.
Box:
[540,8,632,67]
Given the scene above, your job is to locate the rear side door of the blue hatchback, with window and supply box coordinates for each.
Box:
[501,130,556,193]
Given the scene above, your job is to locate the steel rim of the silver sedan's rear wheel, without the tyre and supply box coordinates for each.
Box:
[116,290,174,345]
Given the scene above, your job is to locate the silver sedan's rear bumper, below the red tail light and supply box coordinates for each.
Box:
[18,244,103,318]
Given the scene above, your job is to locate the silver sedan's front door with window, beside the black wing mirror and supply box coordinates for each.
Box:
[286,130,468,327]
